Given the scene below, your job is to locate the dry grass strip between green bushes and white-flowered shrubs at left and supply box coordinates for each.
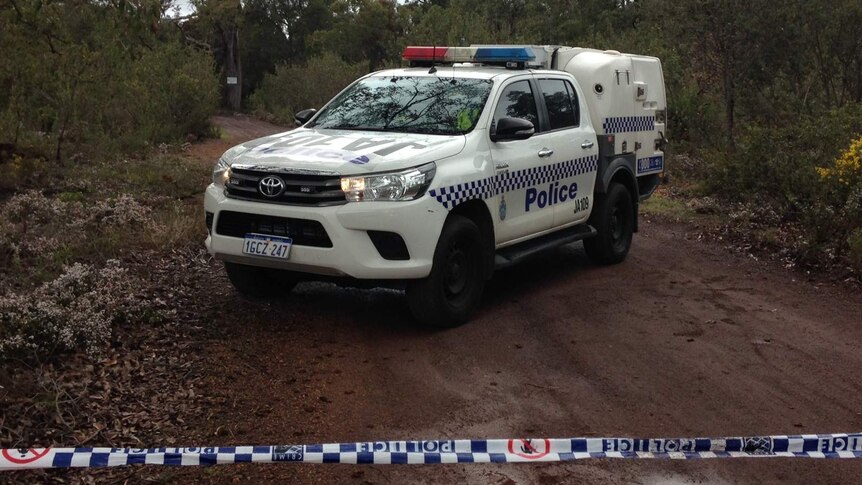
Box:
[0,153,210,295]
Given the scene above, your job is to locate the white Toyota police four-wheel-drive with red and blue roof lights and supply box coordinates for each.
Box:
[205,46,666,326]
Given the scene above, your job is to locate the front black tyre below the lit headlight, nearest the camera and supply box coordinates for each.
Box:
[407,215,488,327]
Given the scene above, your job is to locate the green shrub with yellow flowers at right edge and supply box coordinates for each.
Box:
[704,104,862,265]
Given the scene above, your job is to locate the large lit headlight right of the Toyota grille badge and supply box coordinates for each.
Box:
[341,162,437,202]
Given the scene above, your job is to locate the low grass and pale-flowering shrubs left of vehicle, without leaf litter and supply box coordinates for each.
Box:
[0,154,208,361]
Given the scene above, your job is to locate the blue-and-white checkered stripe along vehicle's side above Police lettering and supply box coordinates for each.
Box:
[428,155,599,209]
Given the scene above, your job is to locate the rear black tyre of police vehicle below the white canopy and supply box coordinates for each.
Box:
[584,183,635,264]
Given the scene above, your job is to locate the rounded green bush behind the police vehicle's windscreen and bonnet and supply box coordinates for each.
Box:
[251,55,367,123]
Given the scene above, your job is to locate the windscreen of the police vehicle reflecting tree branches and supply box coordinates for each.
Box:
[307,76,492,135]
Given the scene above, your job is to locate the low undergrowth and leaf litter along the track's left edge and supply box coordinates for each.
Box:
[0,147,219,482]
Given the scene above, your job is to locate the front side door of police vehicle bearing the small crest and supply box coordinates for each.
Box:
[489,74,554,246]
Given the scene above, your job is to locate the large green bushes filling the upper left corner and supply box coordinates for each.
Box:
[0,0,218,163]
